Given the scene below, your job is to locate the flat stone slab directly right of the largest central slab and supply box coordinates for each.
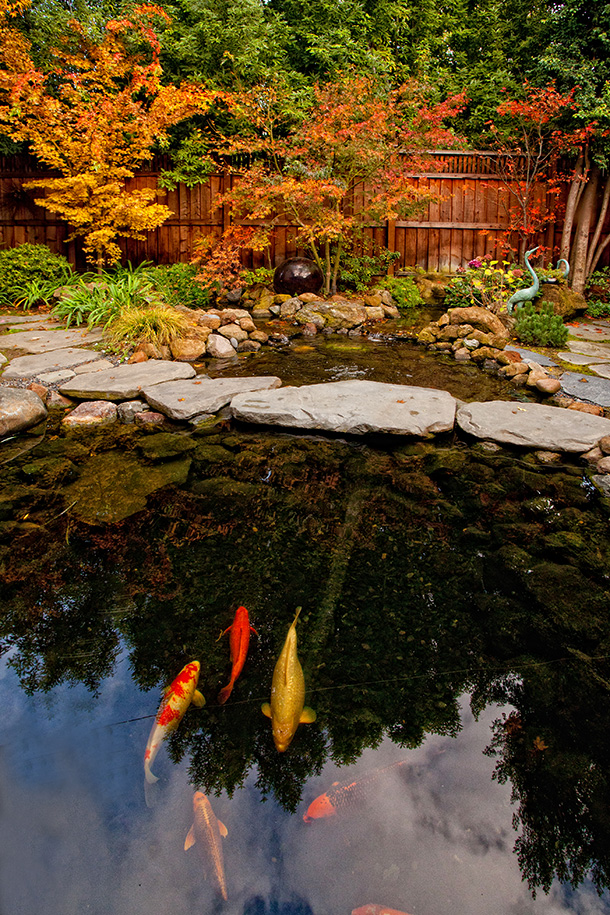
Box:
[456,400,610,454]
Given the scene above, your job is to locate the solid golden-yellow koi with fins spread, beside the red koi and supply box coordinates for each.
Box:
[262,607,316,753]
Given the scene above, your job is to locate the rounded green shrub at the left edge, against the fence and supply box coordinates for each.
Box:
[0,244,73,308]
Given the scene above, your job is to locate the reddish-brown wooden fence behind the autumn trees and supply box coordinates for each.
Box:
[0,151,576,271]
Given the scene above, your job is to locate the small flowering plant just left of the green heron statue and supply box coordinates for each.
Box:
[445,254,528,312]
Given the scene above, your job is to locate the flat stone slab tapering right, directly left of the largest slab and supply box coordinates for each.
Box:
[142,375,282,420]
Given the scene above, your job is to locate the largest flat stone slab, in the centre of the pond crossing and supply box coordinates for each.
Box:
[231,380,457,437]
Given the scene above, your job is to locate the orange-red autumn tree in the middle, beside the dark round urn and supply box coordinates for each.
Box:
[216,75,464,293]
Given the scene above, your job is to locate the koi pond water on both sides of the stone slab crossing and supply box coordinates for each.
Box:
[0,338,610,915]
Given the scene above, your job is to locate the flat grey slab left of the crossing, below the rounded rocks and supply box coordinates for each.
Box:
[59,359,196,400]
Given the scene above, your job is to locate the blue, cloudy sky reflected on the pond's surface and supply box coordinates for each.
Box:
[0,654,609,915]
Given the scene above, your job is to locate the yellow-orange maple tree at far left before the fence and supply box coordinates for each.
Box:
[0,0,213,271]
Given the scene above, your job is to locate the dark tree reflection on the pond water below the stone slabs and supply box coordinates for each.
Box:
[0,431,610,900]
